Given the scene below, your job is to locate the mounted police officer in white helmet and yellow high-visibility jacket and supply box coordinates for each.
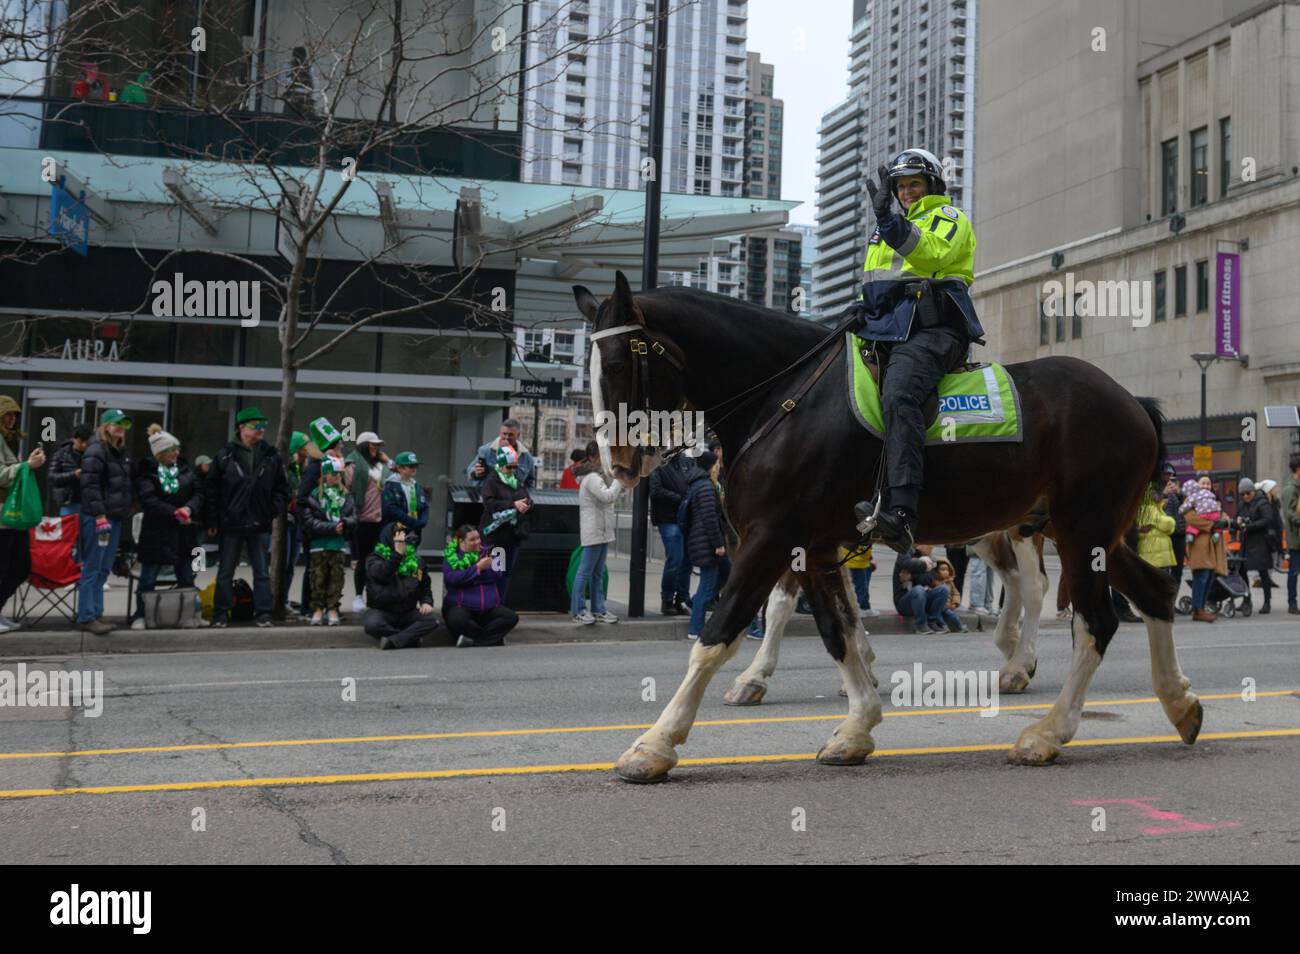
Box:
[854,149,984,552]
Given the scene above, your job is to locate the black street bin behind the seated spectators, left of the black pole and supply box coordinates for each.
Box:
[438,483,579,612]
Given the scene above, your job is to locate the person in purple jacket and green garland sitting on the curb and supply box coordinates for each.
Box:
[442,524,519,646]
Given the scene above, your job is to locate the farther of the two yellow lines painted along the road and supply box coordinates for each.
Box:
[0,689,1300,760]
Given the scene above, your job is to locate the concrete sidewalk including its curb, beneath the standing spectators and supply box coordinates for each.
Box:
[0,548,1067,658]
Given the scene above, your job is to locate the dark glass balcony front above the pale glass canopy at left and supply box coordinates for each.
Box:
[7,96,520,182]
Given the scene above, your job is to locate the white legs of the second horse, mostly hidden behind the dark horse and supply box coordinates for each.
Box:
[723,530,1049,706]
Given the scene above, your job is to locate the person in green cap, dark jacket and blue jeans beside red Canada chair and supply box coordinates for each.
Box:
[77,408,134,636]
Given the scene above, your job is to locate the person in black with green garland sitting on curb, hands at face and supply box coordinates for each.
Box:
[361,524,442,650]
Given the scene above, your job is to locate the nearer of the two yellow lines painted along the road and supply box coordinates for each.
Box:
[0,728,1300,798]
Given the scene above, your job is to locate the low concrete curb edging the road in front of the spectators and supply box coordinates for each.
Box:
[0,613,1069,659]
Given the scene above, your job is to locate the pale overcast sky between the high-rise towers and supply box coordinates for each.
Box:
[748,0,853,225]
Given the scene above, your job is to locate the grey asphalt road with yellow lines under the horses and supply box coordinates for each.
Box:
[0,615,1300,864]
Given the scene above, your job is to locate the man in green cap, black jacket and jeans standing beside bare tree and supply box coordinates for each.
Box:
[204,407,289,626]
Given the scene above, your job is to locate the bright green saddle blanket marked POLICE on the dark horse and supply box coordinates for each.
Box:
[846,331,1024,445]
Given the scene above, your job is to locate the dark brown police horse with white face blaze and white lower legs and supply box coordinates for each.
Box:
[573,272,1201,781]
